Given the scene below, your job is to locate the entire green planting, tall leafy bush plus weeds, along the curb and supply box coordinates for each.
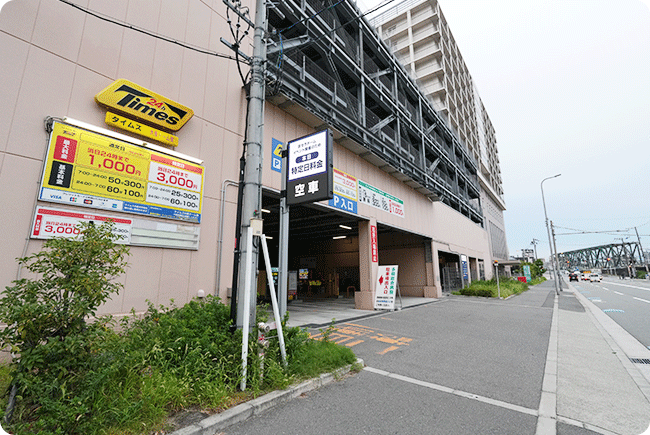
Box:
[0,224,356,435]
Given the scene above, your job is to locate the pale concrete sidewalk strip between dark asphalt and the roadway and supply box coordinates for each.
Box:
[557,285,650,435]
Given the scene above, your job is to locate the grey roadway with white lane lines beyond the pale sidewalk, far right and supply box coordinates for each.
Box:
[572,277,650,348]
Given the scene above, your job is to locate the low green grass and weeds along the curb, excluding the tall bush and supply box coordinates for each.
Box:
[0,297,356,435]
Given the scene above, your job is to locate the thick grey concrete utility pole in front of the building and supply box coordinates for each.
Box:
[233,0,266,327]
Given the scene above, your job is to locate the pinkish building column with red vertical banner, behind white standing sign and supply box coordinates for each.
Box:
[354,218,379,310]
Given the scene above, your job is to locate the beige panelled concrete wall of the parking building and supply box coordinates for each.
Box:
[0,0,487,313]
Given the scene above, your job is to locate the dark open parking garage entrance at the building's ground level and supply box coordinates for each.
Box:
[258,192,434,311]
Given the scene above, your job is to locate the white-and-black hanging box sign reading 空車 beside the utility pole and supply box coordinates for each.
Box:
[287,130,334,205]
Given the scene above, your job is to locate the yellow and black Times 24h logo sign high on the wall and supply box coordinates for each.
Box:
[95,79,194,131]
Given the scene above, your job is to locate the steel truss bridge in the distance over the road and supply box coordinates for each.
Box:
[558,242,644,270]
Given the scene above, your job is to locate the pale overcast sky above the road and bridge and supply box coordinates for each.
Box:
[357,0,650,257]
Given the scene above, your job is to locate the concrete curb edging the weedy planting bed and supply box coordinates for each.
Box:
[170,358,364,435]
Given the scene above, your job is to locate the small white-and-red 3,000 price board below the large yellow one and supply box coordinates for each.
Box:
[31,206,133,244]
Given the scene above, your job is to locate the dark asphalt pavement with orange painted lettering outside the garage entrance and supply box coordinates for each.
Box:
[221,285,595,435]
